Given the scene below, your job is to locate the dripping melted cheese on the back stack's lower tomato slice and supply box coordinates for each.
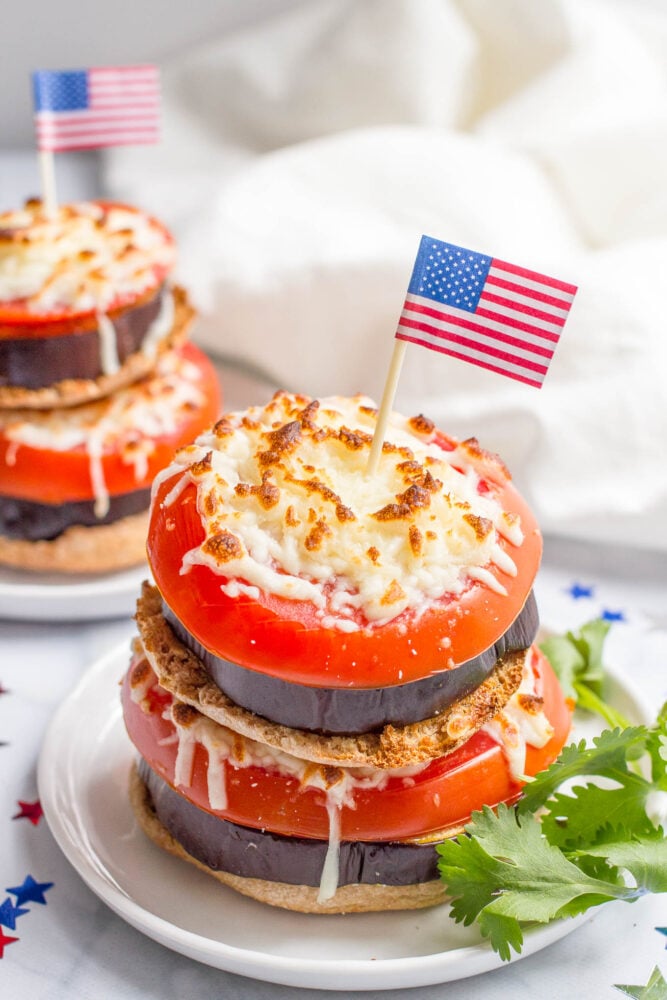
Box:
[0,338,205,518]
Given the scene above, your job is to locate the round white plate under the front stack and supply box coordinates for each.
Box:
[38,643,646,990]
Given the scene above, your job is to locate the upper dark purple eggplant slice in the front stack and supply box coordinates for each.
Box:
[162,591,539,736]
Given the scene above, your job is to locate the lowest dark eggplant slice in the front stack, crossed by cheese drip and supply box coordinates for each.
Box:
[137,758,439,887]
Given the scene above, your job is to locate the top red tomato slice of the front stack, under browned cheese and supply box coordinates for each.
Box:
[148,464,542,687]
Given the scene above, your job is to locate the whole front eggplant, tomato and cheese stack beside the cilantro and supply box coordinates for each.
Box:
[122,392,571,913]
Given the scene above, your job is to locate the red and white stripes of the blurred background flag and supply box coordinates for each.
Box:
[35,66,160,153]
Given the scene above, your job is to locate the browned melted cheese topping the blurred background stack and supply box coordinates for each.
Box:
[0,201,175,316]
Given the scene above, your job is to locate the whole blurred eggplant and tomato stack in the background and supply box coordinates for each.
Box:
[0,200,219,572]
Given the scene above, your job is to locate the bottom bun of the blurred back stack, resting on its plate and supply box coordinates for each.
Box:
[0,511,148,573]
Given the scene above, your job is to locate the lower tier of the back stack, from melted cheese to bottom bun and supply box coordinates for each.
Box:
[0,343,219,573]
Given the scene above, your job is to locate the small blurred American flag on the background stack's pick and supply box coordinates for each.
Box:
[32,66,160,153]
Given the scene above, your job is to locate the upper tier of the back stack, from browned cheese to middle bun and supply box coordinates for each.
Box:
[0,199,193,409]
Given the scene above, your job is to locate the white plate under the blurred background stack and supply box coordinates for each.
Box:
[0,565,149,621]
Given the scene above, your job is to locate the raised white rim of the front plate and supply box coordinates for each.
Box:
[37,639,651,991]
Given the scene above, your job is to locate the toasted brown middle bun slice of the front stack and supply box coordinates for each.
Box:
[135,583,527,768]
